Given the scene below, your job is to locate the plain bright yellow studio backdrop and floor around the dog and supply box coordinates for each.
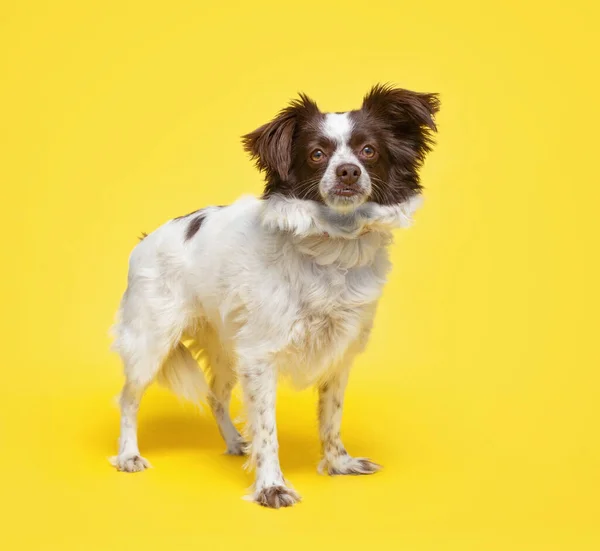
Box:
[0,0,600,551]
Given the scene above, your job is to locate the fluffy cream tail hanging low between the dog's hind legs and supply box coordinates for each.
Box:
[156,343,209,403]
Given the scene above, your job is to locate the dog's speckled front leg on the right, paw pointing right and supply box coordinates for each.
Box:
[319,365,381,475]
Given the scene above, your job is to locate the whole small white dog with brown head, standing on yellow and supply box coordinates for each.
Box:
[112,85,439,508]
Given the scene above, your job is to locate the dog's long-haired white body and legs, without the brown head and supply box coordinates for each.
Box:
[113,192,419,504]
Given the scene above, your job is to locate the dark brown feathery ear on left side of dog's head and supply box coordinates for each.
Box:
[242,94,319,181]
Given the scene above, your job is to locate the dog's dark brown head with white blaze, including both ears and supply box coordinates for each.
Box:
[243,85,439,211]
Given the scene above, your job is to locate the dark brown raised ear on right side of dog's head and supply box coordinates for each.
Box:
[362,84,440,156]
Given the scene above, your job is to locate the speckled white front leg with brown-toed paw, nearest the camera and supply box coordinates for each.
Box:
[240,361,300,509]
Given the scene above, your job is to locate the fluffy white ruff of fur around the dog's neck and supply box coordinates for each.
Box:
[261,195,421,269]
